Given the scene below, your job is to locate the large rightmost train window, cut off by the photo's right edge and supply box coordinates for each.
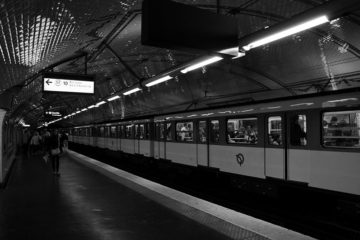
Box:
[322,110,360,148]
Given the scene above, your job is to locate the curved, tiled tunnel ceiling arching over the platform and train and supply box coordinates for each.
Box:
[0,0,360,126]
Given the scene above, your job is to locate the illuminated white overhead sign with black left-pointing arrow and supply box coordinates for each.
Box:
[43,74,95,94]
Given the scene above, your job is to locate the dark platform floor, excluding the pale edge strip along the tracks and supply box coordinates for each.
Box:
[0,155,233,240]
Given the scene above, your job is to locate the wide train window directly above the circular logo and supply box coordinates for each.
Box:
[227,118,258,144]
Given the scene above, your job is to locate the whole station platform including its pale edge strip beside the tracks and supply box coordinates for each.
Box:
[0,150,313,240]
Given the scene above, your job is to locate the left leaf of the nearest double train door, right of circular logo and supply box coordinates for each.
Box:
[265,114,287,179]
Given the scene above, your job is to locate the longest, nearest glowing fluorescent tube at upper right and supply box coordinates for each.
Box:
[242,15,329,51]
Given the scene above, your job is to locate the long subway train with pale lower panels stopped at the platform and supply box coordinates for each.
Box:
[68,90,360,202]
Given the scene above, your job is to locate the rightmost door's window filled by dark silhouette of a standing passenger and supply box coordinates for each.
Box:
[290,115,307,146]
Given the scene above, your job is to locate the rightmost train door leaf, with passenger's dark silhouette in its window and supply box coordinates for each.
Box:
[287,111,310,182]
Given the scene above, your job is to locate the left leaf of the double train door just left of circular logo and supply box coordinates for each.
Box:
[195,120,209,167]
